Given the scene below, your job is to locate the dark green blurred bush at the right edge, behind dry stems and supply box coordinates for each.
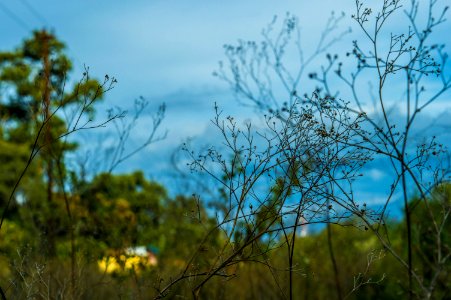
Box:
[391,183,451,299]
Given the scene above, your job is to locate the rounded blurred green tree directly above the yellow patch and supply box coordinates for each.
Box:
[74,172,167,250]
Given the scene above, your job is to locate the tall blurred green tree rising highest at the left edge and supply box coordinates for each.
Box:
[0,30,103,256]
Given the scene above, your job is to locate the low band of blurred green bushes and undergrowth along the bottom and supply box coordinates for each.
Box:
[0,164,451,299]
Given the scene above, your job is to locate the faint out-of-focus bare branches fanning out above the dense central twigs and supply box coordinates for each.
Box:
[214,14,350,113]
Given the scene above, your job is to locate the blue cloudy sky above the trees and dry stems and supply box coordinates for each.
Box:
[0,0,451,214]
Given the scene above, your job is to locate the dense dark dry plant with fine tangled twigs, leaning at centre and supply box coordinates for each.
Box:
[159,96,370,297]
